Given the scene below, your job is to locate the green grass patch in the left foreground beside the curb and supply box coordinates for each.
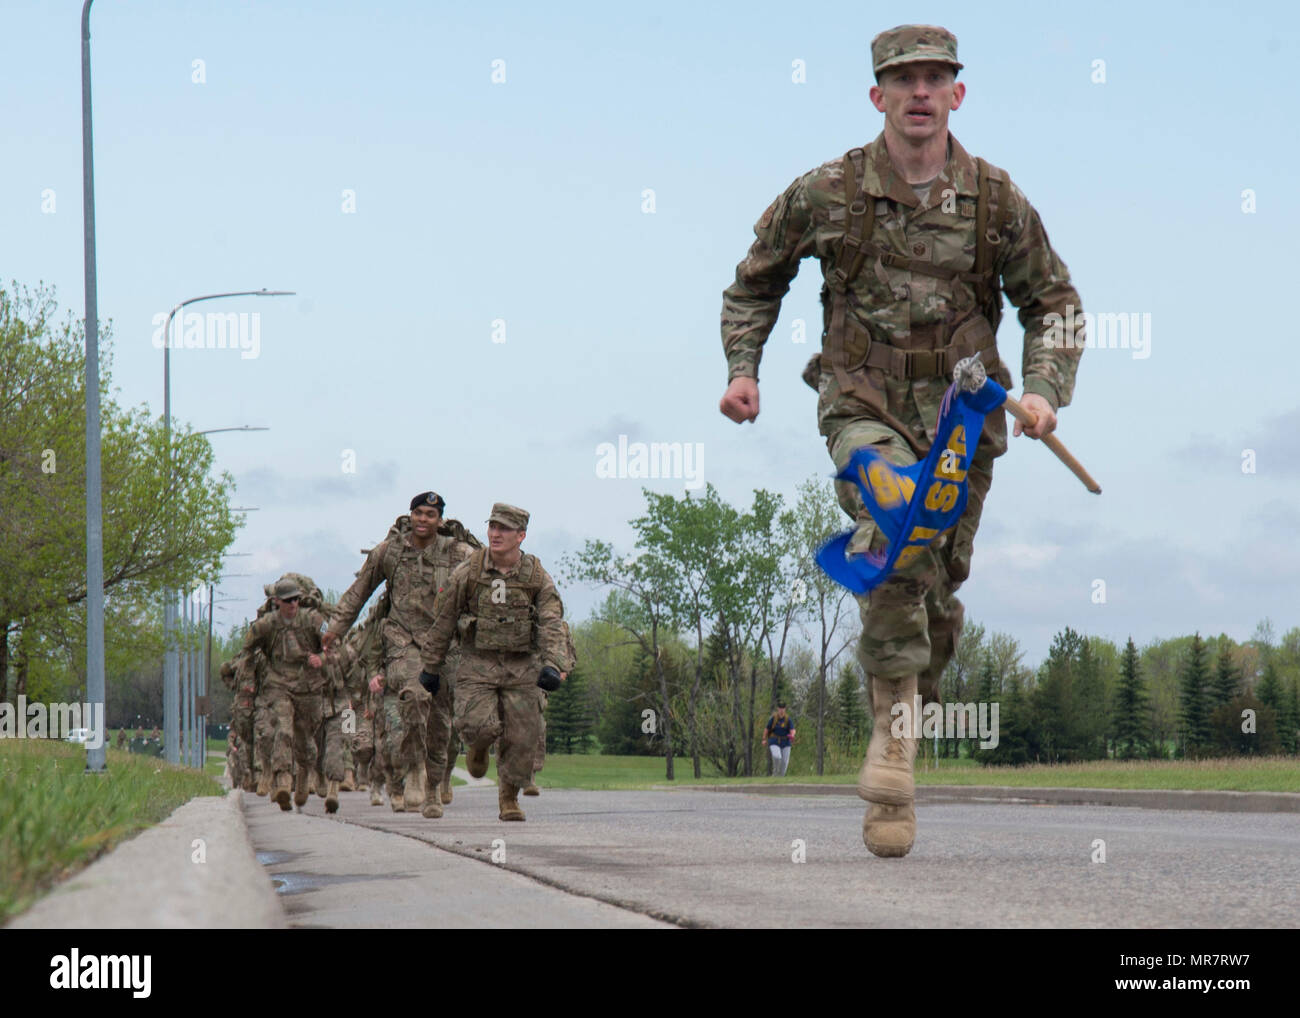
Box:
[0,738,222,923]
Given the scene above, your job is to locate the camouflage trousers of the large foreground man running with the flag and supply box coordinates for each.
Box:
[818,367,1011,701]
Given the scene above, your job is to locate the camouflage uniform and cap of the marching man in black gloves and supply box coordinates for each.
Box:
[424,507,566,788]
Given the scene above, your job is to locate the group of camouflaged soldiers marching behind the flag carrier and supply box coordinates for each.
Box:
[221,491,575,820]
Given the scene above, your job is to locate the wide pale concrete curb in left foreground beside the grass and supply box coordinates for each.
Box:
[8,790,287,930]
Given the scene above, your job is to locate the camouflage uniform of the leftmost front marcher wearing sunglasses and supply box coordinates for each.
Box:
[243,585,325,801]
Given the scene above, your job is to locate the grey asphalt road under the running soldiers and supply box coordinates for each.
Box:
[244,788,1300,928]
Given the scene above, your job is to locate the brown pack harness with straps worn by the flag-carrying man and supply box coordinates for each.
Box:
[805,148,1010,456]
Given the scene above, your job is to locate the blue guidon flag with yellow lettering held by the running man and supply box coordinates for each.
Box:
[816,358,1006,594]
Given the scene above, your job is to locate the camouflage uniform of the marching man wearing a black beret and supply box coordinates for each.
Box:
[330,520,472,807]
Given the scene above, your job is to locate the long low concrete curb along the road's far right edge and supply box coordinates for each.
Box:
[655,784,1300,813]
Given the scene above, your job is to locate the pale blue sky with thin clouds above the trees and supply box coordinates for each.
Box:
[0,0,1300,659]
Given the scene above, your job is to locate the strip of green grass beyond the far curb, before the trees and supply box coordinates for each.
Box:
[488,754,1300,792]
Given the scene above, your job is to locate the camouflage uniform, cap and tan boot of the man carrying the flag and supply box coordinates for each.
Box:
[722,25,1082,857]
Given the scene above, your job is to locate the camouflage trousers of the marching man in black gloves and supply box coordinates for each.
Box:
[456,650,542,788]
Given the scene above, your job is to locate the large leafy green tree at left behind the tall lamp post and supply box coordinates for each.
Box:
[0,285,239,699]
